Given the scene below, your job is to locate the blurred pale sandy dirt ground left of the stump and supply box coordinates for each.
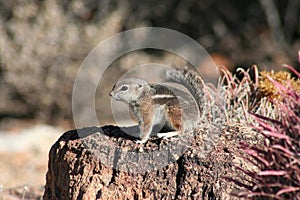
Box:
[0,124,63,200]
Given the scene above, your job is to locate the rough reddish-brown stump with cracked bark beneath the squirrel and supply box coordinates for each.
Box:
[43,126,253,199]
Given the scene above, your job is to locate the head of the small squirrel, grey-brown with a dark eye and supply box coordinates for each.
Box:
[109,78,150,103]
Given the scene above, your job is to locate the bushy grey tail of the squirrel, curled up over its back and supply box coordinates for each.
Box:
[166,69,205,113]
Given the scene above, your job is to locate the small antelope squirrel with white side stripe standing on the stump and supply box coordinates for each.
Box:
[109,69,205,143]
